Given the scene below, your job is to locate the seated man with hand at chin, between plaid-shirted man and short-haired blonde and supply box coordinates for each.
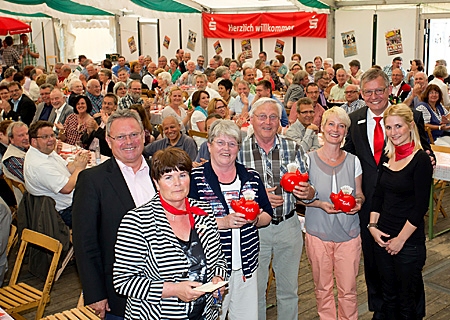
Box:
[285,97,320,152]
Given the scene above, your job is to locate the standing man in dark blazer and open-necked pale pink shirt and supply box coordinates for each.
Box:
[72,110,155,319]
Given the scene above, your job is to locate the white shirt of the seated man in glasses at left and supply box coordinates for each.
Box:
[23,146,73,211]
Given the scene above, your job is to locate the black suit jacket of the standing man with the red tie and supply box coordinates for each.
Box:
[343,106,433,227]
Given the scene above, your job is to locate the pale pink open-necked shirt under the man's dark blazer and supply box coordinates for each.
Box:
[116,157,156,207]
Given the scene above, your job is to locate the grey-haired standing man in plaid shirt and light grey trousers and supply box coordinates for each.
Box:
[238,98,315,320]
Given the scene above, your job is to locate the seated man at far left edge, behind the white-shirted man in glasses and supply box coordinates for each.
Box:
[2,121,30,183]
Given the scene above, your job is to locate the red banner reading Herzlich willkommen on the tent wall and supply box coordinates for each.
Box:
[202,12,327,39]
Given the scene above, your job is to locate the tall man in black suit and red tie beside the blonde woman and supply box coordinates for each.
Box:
[344,69,431,319]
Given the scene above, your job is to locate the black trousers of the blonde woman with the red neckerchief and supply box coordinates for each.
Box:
[375,244,426,320]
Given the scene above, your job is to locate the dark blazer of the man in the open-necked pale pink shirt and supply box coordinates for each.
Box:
[72,158,151,317]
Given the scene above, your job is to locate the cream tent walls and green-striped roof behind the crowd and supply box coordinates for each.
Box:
[0,0,450,73]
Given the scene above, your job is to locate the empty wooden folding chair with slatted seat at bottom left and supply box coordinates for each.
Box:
[0,229,62,319]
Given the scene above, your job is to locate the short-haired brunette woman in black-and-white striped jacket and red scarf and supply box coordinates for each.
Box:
[113,148,227,320]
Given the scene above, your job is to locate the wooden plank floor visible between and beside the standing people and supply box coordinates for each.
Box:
[5,199,450,320]
